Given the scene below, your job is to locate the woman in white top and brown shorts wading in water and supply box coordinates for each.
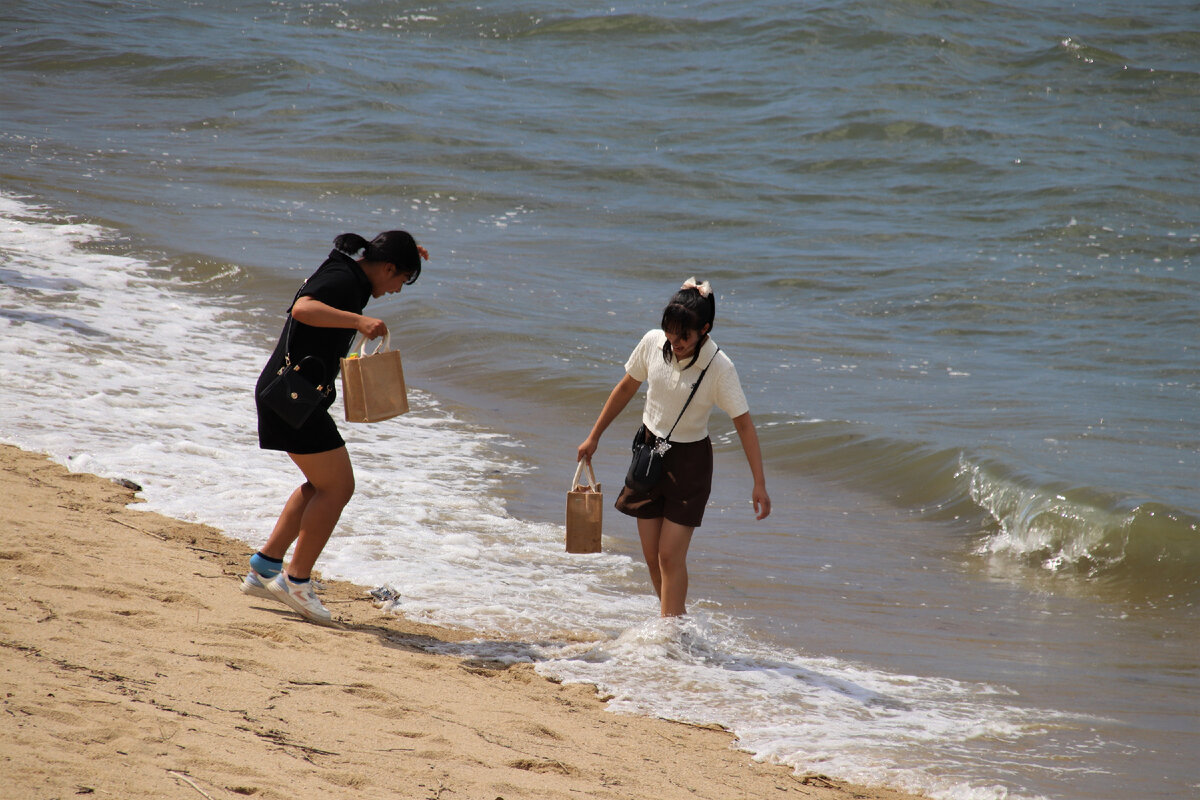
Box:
[577,278,770,616]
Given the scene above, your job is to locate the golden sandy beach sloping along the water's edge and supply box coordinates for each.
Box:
[0,446,911,800]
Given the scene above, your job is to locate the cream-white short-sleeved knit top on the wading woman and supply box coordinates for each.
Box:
[625,329,750,443]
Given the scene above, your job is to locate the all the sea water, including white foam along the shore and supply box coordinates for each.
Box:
[0,1,1200,800]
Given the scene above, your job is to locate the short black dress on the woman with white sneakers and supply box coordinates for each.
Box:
[254,249,371,455]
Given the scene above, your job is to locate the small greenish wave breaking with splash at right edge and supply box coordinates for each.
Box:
[768,420,1200,602]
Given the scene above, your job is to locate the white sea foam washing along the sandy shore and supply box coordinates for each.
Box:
[0,196,1052,800]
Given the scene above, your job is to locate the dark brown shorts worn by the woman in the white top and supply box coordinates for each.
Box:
[616,438,713,528]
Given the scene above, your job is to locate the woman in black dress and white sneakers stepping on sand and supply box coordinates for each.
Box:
[241,230,430,622]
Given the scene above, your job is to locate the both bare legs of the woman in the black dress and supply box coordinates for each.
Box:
[262,447,354,578]
